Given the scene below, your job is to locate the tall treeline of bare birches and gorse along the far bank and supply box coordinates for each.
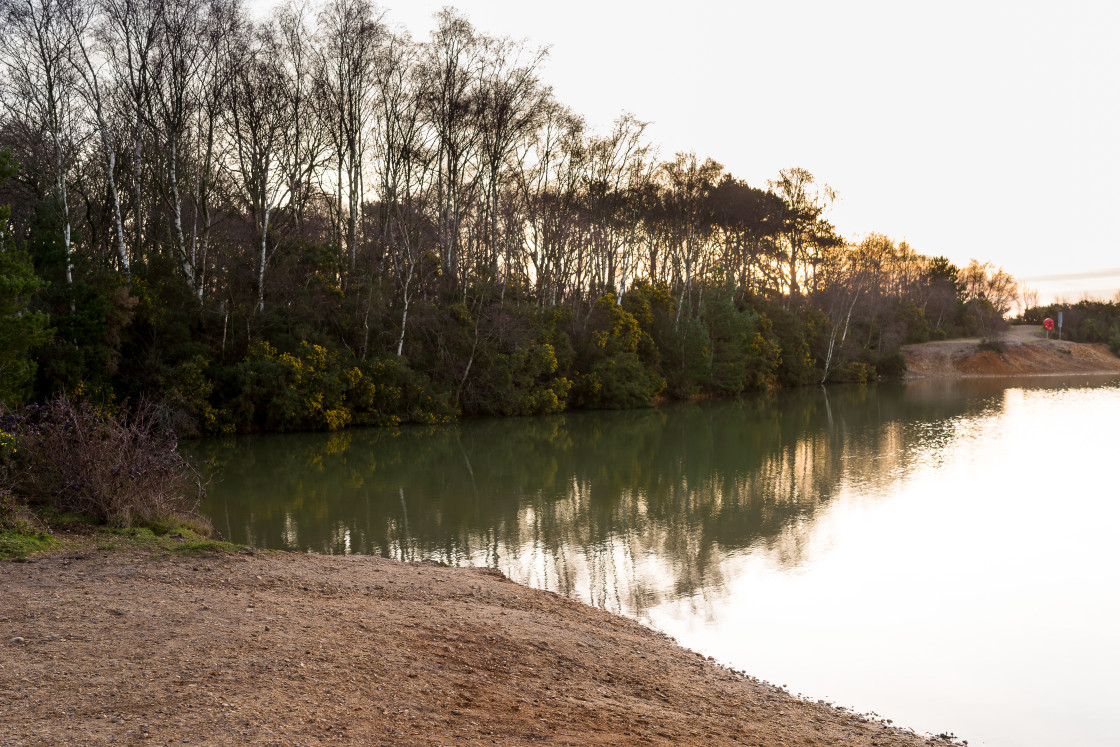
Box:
[0,0,1015,432]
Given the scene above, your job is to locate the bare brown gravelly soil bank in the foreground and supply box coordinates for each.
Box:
[0,542,958,746]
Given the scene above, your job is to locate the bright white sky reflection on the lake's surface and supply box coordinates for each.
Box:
[648,386,1120,745]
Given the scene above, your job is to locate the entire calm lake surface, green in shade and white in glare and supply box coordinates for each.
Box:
[192,377,1120,746]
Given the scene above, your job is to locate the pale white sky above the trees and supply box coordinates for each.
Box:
[260,0,1120,301]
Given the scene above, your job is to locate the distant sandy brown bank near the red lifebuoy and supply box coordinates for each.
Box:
[903,325,1120,379]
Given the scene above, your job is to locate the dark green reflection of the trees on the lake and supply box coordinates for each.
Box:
[195,382,1061,617]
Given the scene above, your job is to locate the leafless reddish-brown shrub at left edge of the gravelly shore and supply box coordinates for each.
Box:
[0,399,211,533]
